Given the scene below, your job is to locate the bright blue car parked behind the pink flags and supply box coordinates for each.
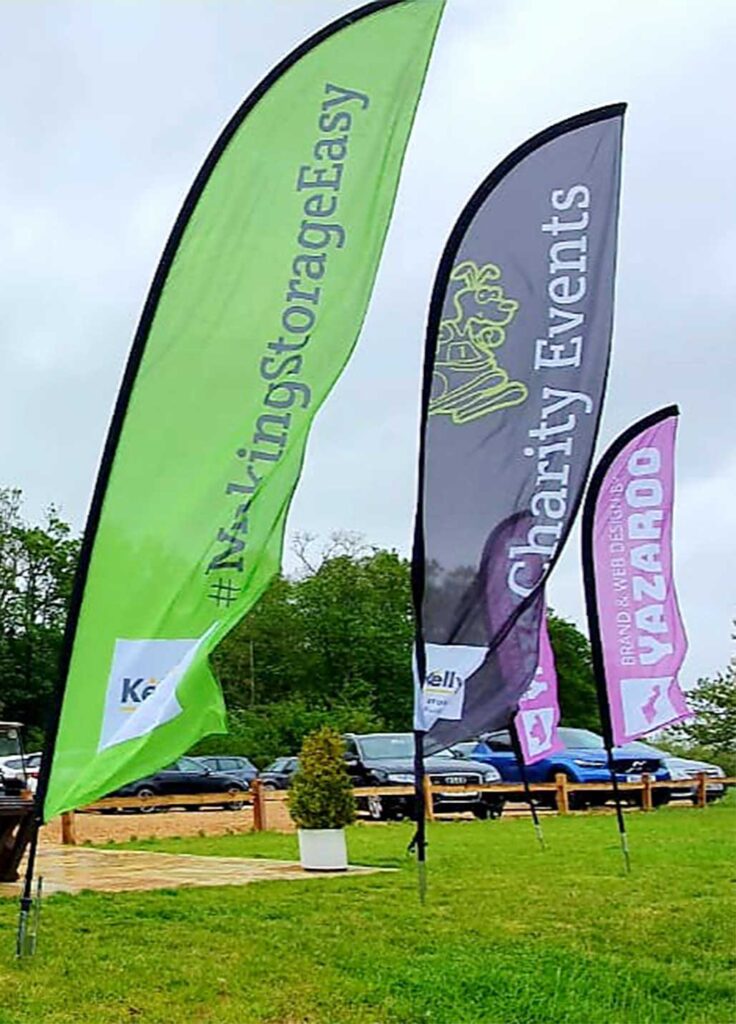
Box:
[452,727,669,807]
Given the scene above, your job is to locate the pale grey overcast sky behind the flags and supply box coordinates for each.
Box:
[0,0,736,685]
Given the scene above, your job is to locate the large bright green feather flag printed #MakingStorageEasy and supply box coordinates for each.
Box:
[40,0,443,820]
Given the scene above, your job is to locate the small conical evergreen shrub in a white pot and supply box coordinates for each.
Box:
[289,726,355,871]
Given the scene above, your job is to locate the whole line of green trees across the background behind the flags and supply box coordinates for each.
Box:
[0,488,736,770]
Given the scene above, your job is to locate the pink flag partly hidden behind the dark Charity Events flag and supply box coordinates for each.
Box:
[515,614,563,765]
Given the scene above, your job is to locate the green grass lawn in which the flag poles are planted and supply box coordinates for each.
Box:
[0,804,736,1024]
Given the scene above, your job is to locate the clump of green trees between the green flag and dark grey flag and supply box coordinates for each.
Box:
[216,535,414,729]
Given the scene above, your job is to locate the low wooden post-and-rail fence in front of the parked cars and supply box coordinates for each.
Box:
[56,772,736,846]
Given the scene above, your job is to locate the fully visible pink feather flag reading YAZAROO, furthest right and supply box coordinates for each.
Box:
[583,406,690,744]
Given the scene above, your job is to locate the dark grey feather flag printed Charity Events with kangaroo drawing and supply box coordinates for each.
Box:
[413,104,624,753]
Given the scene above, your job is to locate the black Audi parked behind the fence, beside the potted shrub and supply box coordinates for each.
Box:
[343,732,505,820]
